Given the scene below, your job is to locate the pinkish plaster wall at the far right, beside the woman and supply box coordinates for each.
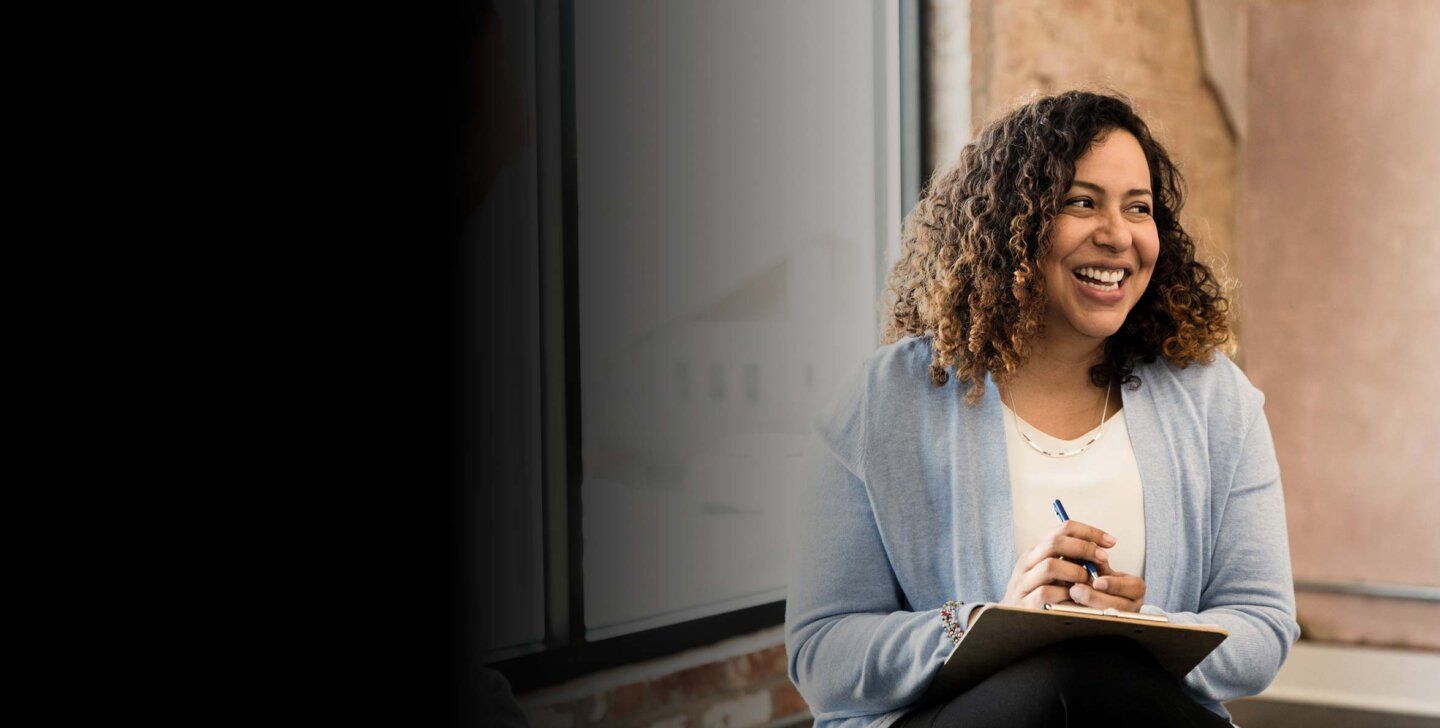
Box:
[1237,0,1440,649]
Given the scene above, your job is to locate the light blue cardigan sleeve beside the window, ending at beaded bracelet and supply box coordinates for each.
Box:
[785,364,973,721]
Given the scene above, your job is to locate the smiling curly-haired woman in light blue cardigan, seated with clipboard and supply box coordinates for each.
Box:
[786,92,1299,727]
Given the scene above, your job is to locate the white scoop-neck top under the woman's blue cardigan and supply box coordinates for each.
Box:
[1001,401,1145,575]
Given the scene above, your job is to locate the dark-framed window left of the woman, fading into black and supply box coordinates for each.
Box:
[461,0,920,689]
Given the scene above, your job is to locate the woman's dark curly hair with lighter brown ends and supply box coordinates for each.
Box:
[883,91,1230,404]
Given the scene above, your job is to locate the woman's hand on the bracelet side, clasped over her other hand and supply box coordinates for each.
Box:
[1001,521,1117,611]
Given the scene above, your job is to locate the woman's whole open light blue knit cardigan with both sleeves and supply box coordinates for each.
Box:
[785,337,1300,727]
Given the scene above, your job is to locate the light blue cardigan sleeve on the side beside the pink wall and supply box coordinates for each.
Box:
[1142,393,1300,702]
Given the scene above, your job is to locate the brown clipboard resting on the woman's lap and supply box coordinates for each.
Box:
[920,604,1230,704]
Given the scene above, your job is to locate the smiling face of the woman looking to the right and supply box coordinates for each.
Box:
[1041,129,1161,342]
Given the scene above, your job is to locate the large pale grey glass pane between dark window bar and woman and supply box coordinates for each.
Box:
[575,0,886,639]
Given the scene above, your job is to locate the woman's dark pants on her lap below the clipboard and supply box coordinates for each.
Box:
[894,637,1230,728]
